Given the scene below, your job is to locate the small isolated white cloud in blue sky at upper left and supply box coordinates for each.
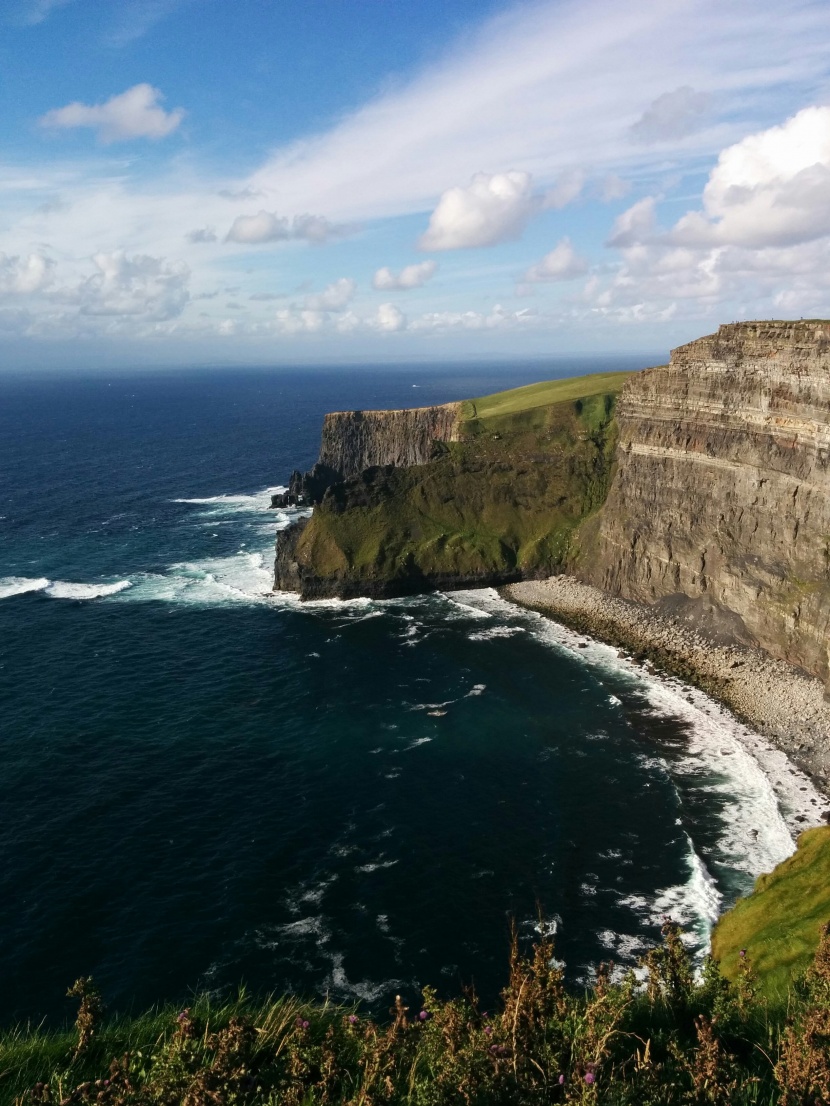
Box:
[39,84,185,143]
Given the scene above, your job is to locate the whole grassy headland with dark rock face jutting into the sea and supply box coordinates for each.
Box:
[274,374,626,598]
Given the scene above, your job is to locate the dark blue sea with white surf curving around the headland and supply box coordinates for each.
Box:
[0,363,805,1022]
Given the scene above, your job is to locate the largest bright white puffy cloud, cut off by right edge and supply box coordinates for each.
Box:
[673,107,830,249]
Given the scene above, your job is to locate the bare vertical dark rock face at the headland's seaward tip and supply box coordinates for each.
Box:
[271,404,461,508]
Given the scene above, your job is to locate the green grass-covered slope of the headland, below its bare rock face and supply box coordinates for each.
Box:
[297,373,629,595]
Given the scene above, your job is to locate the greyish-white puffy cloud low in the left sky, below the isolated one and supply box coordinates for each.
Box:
[72,251,190,322]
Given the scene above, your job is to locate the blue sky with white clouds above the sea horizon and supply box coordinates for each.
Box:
[0,0,830,369]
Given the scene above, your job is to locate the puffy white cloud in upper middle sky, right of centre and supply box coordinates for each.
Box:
[418,171,540,250]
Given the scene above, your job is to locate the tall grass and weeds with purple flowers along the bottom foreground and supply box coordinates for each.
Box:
[0,922,830,1106]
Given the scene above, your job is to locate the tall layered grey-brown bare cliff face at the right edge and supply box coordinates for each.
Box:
[580,321,830,678]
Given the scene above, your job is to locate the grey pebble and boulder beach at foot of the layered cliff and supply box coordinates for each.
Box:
[500,576,830,795]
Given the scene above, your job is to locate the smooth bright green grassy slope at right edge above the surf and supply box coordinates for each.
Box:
[712,826,830,1002]
